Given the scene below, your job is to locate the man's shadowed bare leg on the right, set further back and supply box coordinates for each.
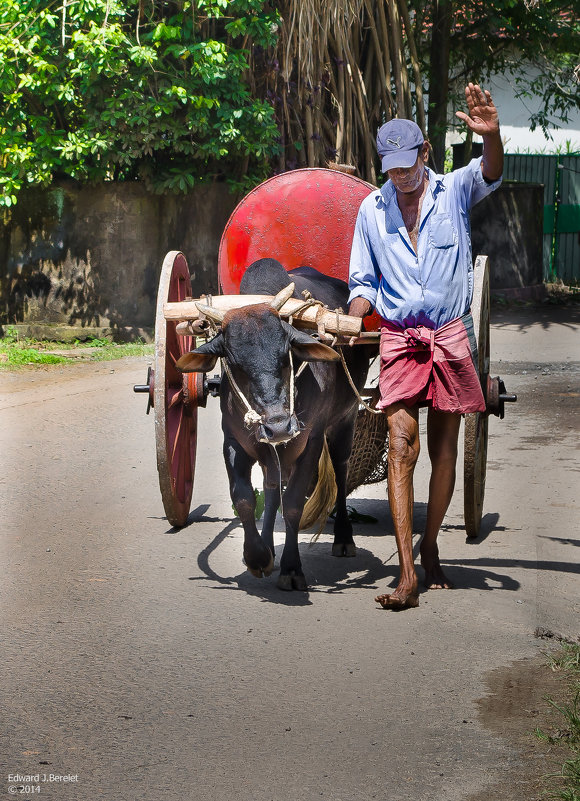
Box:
[421,409,461,589]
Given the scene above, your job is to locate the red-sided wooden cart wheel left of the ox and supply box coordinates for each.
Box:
[153,250,203,526]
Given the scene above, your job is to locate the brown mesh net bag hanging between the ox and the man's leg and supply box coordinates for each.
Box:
[346,389,389,495]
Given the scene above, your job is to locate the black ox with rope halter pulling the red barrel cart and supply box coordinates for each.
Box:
[177,259,369,590]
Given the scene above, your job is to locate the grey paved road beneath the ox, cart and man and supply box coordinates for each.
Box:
[0,306,580,801]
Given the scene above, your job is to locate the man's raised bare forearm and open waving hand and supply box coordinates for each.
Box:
[455,83,503,181]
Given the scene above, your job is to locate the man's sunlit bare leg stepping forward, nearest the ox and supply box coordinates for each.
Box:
[375,403,419,609]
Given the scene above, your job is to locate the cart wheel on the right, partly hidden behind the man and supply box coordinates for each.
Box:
[463,256,490,538]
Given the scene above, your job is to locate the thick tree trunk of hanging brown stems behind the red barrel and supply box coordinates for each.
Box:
[270,0,423,183]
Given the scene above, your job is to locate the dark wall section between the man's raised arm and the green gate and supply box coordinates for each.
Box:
[471,181,544,290]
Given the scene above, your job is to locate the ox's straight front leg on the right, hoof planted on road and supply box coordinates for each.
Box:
[278,439,322,592]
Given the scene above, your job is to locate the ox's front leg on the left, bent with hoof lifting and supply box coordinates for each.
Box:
[224,437,274,578]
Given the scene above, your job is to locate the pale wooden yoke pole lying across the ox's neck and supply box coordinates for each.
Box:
[163,295,362,338]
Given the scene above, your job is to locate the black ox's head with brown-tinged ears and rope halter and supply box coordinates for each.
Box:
[177,296,340,444]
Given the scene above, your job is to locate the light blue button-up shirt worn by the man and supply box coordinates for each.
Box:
[349,158,501,329]
